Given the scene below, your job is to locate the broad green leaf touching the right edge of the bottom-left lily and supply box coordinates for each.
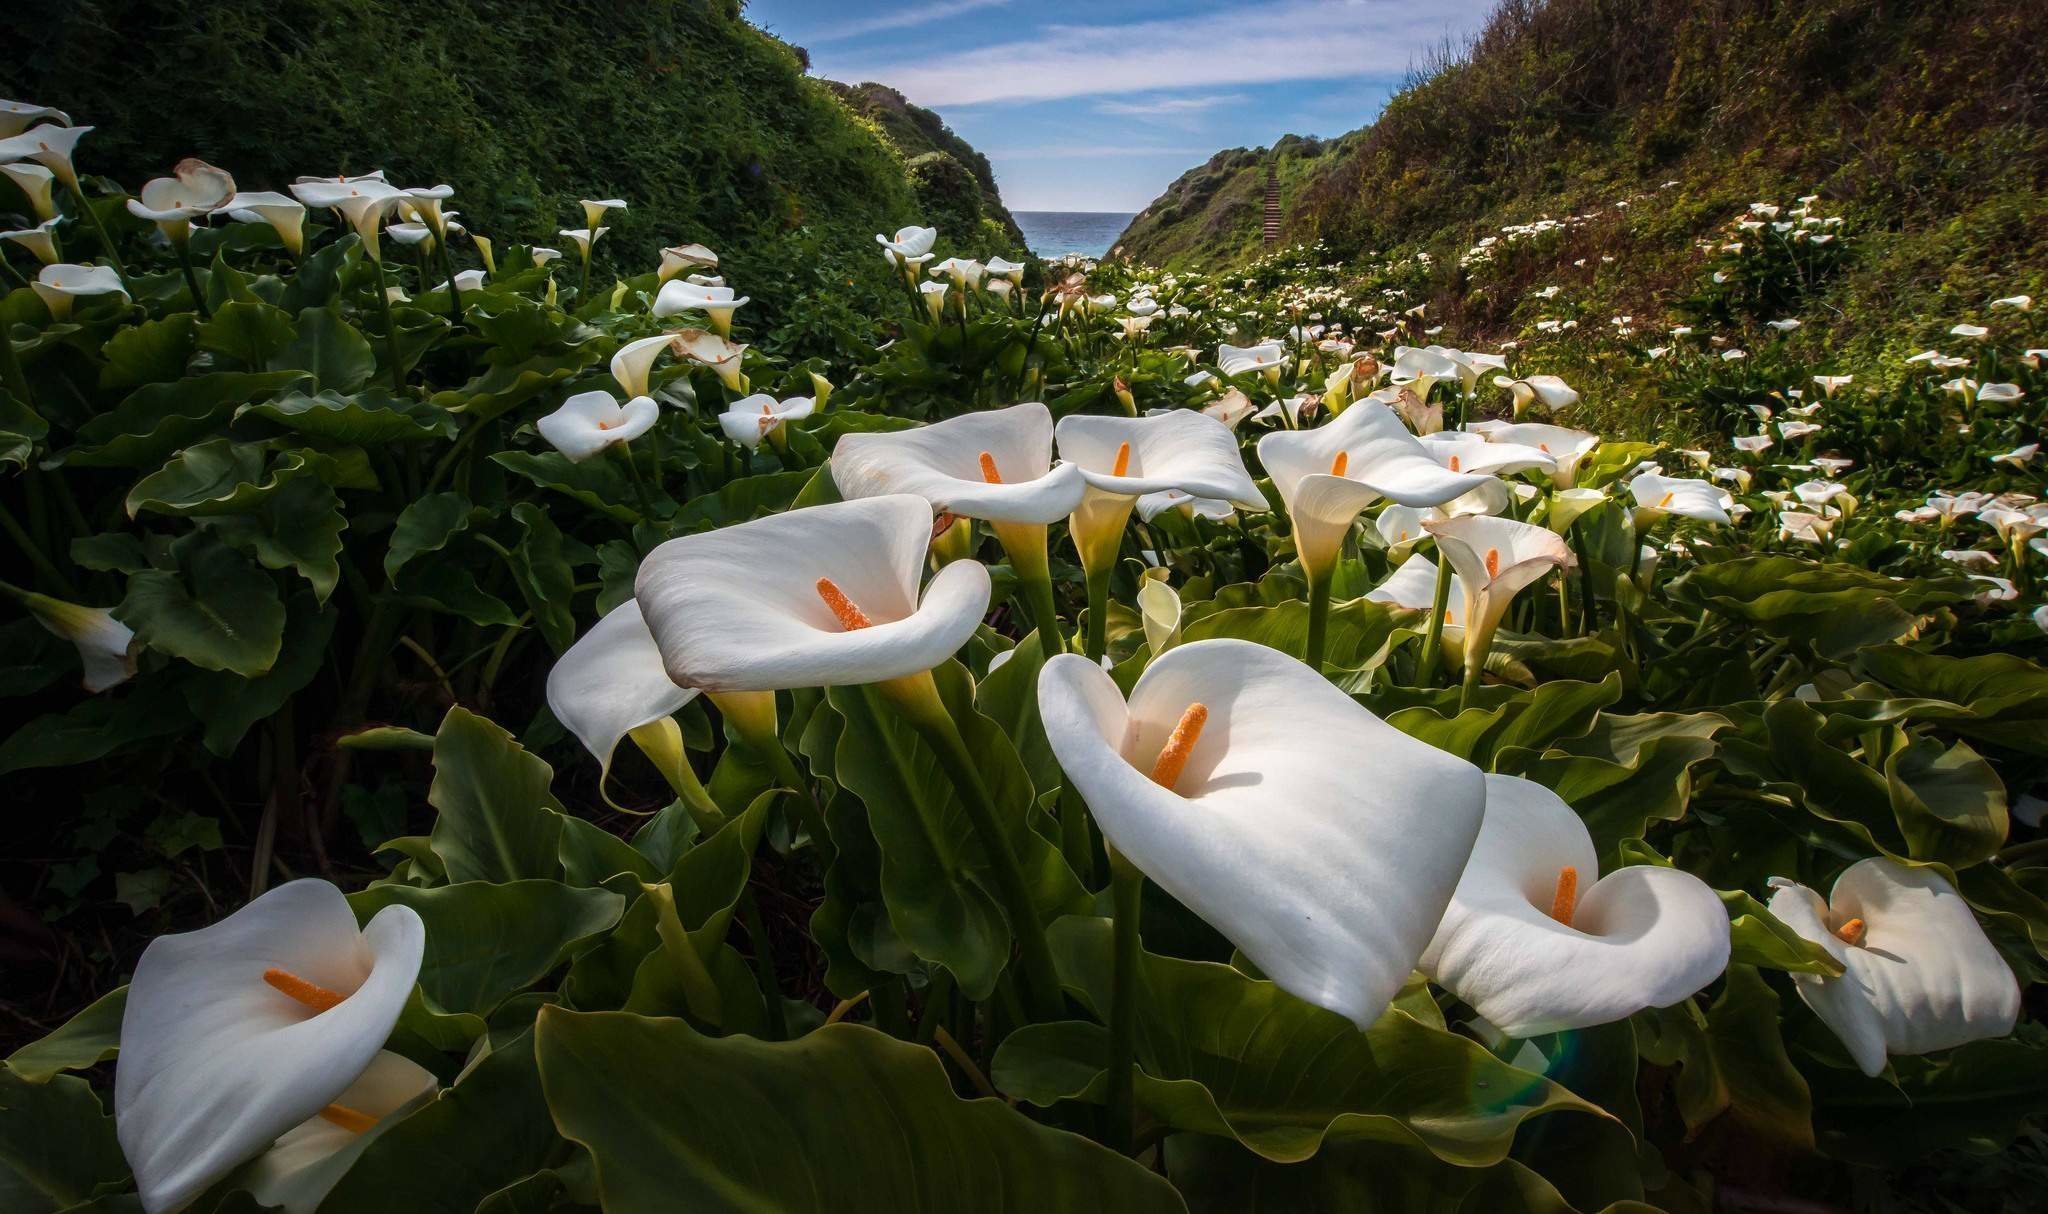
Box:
[348,880,625,1015]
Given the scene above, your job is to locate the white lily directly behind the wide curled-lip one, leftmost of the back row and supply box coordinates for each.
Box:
[831,401,1085,526]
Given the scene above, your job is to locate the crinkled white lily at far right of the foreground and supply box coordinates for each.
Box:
[1769,856,2019,1075]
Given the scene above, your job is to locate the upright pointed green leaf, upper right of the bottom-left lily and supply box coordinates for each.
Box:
[426,706,561,882]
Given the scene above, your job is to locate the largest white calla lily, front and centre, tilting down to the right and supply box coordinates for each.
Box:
[1038,639,1485,1028]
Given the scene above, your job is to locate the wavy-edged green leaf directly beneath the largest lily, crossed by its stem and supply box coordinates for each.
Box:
[995,917,1608,1167]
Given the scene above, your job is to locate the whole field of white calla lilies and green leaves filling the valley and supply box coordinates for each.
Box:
[0,102,2048,1214]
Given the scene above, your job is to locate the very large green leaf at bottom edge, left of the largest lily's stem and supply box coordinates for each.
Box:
[537,1007,1184,1214]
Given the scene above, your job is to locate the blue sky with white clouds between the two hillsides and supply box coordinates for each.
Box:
[745,0,1493,211]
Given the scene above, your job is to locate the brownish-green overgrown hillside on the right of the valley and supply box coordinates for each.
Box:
[1122,0,2048,364]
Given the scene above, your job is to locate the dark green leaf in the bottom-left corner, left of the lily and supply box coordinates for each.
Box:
[0,1065,129,1214]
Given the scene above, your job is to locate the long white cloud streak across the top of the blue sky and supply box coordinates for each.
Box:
[829,0,1493,106]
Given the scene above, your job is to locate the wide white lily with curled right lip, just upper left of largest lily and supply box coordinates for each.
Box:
[635,493,989,679]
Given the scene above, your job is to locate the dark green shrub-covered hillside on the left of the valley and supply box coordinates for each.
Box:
[0,0,1014,339]
